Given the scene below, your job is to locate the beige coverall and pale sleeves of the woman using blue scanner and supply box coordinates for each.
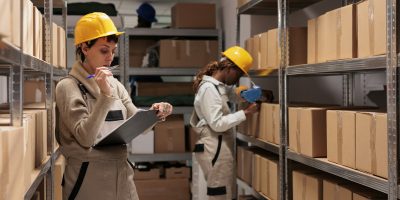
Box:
[190,75,246,200]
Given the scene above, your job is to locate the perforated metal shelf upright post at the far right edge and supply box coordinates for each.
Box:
[386,0,400,200]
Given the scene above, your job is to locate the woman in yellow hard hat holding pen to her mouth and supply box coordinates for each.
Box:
[56,12,172,200]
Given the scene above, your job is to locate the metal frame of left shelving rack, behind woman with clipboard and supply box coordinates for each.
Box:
[0,0,67,199]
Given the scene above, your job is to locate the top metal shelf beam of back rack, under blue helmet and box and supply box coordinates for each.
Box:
[125,28,219,38]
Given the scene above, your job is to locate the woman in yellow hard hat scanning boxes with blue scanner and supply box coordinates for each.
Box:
[190,46,258,200]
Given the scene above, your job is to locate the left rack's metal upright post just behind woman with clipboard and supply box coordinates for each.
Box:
[44,0,55,199]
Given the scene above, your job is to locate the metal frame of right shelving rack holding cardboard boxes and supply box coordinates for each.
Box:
[237,0,400,200]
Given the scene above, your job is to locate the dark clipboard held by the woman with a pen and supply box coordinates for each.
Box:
[94,110,159,147]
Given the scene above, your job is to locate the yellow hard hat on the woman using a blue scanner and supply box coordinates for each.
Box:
[222,46,253,75]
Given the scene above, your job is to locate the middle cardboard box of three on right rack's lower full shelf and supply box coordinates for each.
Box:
[326,110,356,169]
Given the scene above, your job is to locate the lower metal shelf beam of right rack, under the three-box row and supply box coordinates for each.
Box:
[287,150,388,193]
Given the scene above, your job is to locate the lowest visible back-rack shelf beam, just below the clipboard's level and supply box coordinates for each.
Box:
[129,152,192,162]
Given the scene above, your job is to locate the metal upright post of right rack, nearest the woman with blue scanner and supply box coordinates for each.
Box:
[278,0,291,200]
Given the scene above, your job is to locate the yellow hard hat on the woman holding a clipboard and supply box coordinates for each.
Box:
[75,12,124,45]
